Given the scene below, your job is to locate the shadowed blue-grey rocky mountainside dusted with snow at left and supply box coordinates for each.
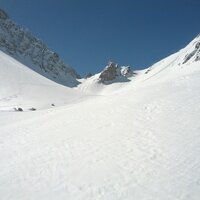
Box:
[0,9,80,87]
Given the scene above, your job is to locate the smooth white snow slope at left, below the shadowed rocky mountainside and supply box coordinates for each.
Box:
[0,51,84,111]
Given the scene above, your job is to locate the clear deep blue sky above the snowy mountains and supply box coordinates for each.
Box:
[0,0,200,75]
